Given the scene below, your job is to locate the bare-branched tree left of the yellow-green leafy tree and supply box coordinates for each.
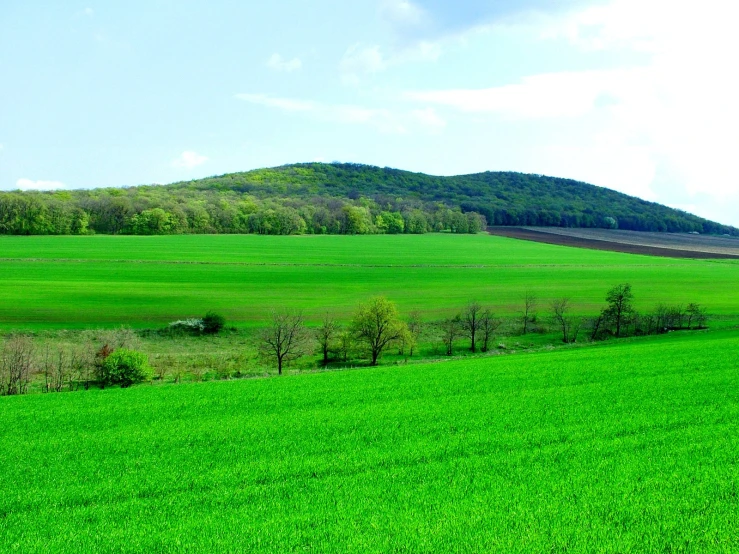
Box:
[260,309,310,375]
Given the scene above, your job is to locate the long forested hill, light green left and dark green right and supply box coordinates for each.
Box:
[0,163,739,236]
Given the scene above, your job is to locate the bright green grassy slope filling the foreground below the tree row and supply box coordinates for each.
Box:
[0,331,739,552]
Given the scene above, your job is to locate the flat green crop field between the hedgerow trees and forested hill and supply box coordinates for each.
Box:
[0,234,739,329]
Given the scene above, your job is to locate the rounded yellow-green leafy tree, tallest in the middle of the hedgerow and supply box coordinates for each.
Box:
[351,296,408,366]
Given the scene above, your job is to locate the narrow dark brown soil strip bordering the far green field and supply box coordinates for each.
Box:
[488,227,739,260]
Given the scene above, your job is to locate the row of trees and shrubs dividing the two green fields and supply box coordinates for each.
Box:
[0,283,708,395]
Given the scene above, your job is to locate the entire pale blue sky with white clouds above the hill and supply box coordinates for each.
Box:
[0,0,739,226]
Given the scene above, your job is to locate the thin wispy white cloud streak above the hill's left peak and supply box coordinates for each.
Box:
[235,94,445,134]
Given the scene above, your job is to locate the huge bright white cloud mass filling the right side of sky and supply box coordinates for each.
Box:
[405,0,739,224]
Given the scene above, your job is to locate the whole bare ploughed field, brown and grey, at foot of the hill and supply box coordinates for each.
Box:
[488,227,739,259]
